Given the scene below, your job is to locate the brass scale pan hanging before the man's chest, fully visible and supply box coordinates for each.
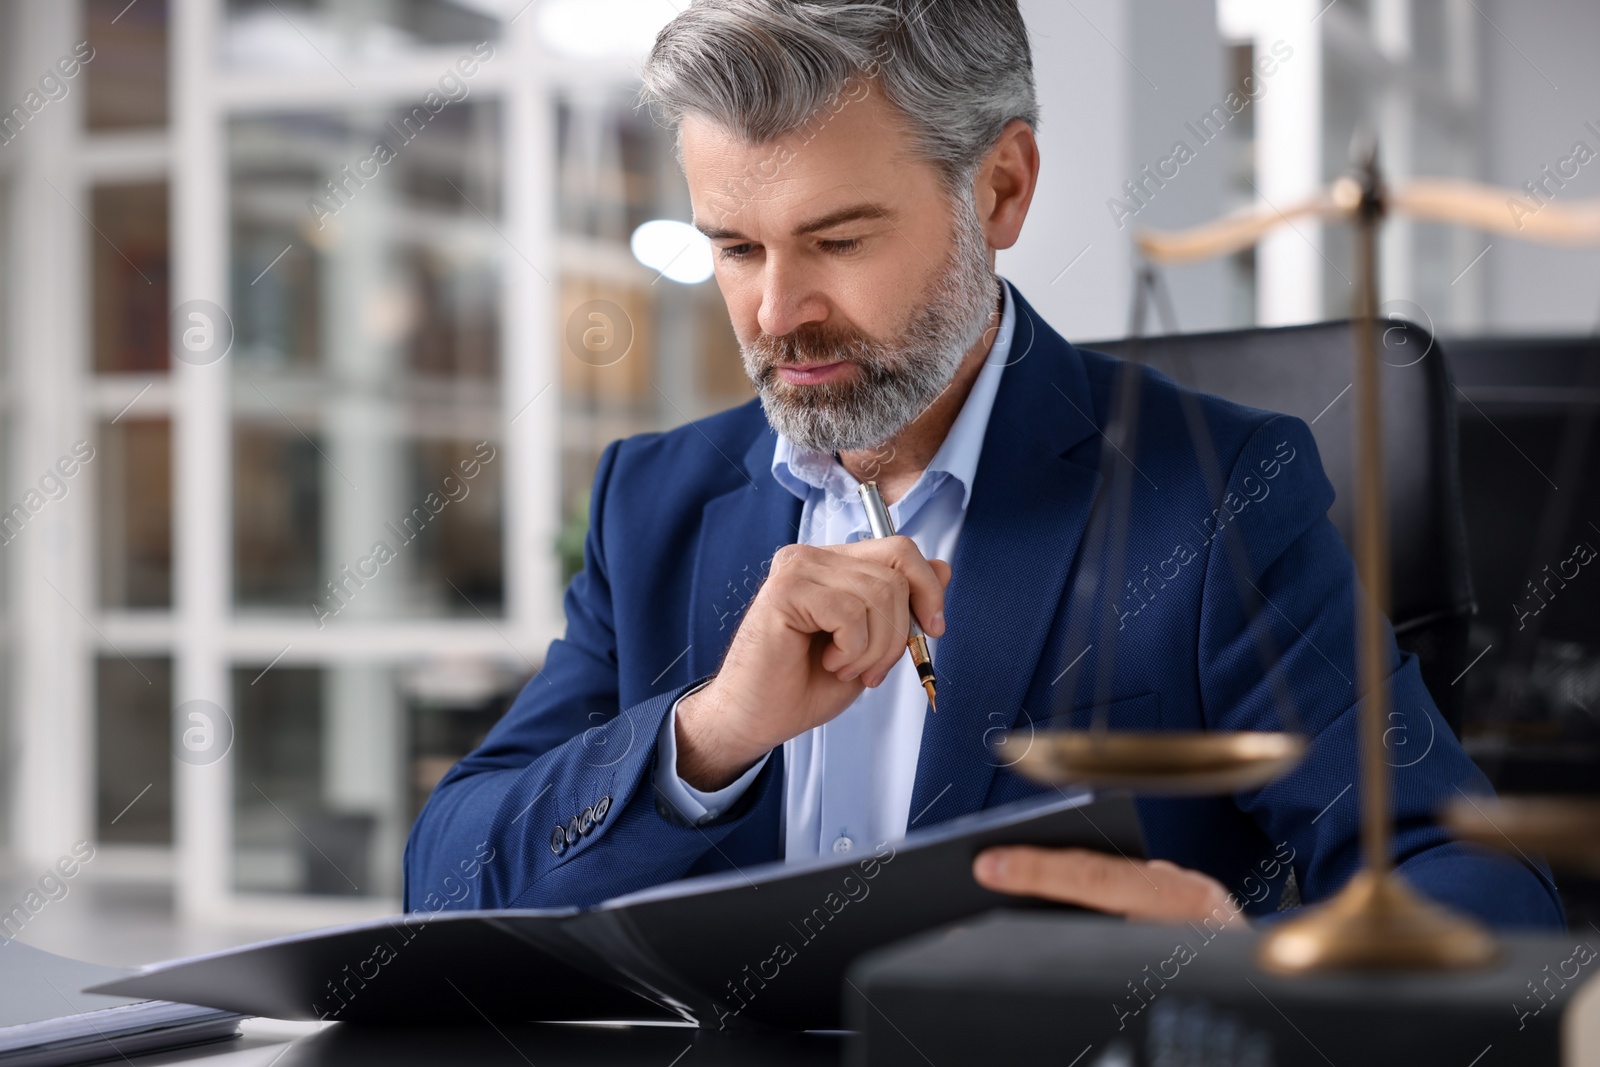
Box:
[995,729,1306,797]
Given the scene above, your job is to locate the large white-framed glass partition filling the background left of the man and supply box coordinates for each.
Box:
[10,0,732,923]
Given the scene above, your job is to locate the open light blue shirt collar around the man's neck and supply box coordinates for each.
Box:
[773,280,1016,510]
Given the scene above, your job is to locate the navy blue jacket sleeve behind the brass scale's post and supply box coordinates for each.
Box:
[1198,416,1565,928]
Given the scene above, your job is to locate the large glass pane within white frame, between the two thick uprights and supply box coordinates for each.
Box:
[229,101,504,617]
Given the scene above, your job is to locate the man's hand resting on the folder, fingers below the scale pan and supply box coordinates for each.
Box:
[973,846,1245,926]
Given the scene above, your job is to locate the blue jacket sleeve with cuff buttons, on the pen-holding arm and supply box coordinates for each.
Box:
[405,443,781,912]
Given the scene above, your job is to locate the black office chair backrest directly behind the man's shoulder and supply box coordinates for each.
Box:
[1082,320,1477,734]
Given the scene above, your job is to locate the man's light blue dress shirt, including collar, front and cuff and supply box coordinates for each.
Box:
[656,283,1016,862]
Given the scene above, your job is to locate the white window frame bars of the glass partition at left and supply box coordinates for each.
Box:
[0,0,635,926]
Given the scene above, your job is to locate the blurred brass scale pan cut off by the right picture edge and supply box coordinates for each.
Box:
[1443,797,1600,878]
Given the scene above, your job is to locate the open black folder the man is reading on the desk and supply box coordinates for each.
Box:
[94,795,1144,1030]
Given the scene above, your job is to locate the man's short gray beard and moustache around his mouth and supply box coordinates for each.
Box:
[742,203,998,454]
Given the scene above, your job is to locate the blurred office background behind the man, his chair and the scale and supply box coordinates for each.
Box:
[0,0,1600,963]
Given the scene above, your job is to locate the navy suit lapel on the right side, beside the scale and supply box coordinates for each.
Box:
[909,288,1101,829]
